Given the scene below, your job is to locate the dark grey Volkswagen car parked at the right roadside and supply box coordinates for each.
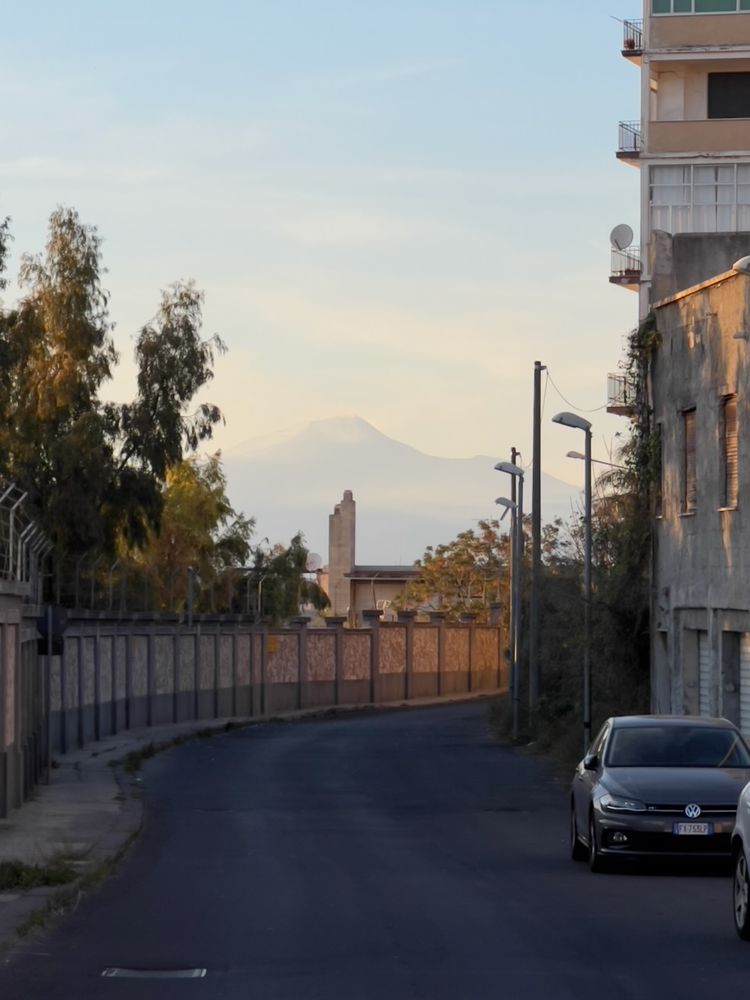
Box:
[570,715,750,872]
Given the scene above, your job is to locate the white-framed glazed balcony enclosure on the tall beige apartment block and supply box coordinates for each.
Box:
[649,163,750,233]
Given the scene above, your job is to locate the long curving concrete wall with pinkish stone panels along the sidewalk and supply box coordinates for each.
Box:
[0,601,508,816]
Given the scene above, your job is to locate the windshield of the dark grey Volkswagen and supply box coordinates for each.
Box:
[607,725,750,767]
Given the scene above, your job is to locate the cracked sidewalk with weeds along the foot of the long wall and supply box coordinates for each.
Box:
[0,691,497,955]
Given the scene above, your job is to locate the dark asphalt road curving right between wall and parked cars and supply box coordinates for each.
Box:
[0,704,750,1000]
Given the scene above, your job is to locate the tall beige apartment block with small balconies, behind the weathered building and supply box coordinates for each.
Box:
[610,0,750,317]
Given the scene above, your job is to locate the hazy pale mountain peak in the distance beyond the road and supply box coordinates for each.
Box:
[223,417,580,565]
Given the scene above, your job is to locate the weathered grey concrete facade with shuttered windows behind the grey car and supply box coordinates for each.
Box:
[650,262,750,734]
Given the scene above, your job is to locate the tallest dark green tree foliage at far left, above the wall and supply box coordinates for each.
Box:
[0,208,223,557]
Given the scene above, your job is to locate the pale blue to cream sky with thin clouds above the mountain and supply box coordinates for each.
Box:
[0,0,639,482]
